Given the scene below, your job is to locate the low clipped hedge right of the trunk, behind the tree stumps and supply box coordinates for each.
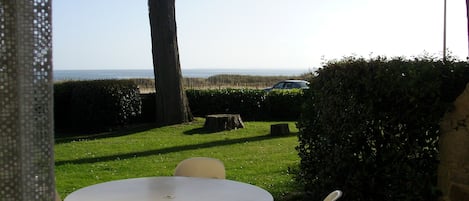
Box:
[186,89,303,120]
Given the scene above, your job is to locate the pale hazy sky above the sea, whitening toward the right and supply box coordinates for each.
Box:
[52,0,468,70]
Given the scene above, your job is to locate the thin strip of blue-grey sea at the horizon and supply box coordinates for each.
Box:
[53,68,312,81]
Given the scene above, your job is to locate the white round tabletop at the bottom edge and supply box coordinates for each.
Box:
[64,176,274,201]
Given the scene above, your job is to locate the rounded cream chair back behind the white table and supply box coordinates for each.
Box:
[174,157,226,179]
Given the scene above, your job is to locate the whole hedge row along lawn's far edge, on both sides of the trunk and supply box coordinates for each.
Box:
[54,83,303,133]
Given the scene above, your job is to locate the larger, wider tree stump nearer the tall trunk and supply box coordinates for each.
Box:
[204,114,244,132]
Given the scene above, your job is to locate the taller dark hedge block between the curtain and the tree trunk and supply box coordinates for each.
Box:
[54,80,141,134]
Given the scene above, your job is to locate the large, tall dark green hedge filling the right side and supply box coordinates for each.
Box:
[297,58,469,201]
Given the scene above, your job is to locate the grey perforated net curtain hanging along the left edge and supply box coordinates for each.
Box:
[0,0,55,201]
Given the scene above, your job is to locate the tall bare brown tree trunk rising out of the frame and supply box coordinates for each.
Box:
[148,0,193,125]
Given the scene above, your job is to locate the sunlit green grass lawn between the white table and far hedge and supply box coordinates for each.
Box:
[55,118,299,200]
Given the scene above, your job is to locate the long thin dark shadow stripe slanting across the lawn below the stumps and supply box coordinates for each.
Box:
[55,134,294,166]
